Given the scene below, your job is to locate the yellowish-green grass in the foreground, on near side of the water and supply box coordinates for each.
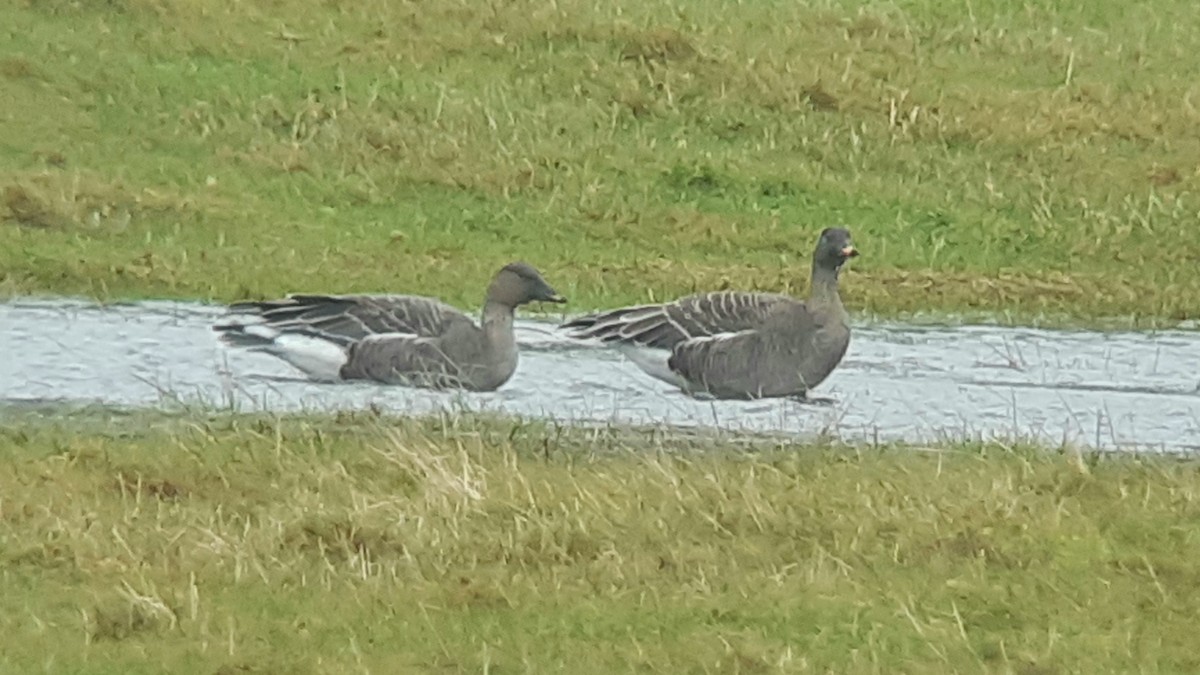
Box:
[0,414,1200,675]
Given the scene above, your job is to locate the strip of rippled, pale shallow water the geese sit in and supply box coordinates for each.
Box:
[0,300,1200,450]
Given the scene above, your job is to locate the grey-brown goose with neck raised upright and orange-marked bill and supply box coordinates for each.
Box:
[559,227,858,400]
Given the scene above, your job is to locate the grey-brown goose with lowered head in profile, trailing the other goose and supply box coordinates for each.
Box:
[214,262,566,392]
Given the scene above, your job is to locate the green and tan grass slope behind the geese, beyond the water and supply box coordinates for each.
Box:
[0,0,1200,323]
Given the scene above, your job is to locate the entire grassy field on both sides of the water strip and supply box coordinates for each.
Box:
[0,0,1200,675]
